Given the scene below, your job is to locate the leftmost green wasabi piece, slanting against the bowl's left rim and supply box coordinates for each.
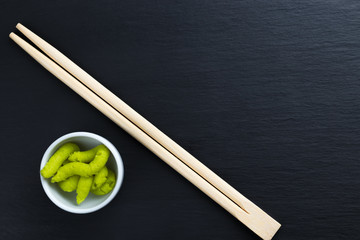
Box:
[40,143,79,178]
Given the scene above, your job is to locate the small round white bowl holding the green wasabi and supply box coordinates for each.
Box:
[40,132,124,214]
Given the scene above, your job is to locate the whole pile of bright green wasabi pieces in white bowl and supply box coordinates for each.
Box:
[41,143,116,204]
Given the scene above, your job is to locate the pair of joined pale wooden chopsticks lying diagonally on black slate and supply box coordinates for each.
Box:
[10,24,281,239]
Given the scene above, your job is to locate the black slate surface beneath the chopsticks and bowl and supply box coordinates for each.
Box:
[0,0,360,240]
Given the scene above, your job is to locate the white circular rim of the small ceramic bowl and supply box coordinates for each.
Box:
[40,132,124,214]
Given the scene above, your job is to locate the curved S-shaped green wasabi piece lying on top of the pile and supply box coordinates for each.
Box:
[51,145,110,182]
